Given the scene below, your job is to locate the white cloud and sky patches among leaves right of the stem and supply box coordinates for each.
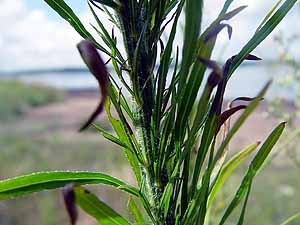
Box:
[207,0,300,59]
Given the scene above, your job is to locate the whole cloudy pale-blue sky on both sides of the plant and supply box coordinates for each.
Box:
[0,0,300,71]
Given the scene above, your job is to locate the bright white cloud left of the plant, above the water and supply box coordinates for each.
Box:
[0,0,81,70]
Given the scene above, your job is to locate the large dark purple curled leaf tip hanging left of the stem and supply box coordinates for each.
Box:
[77,40,109,131]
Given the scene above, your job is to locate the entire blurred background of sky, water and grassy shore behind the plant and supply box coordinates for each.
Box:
[0,0,300,225]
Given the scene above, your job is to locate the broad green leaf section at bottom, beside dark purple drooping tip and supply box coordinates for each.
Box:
[74,186,130,225]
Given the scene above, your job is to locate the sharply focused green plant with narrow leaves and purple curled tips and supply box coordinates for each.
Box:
[0,0,297,225]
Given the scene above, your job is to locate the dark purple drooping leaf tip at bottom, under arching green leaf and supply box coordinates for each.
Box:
[62,184,78,225]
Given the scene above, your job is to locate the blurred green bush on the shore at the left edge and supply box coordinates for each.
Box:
[0,80,64,121]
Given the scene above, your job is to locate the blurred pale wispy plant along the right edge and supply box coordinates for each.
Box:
[269,29,300,168]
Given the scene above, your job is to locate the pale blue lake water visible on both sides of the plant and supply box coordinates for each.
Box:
[1,64,293,99]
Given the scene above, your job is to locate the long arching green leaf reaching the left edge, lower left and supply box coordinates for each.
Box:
[0,171,139,200]
